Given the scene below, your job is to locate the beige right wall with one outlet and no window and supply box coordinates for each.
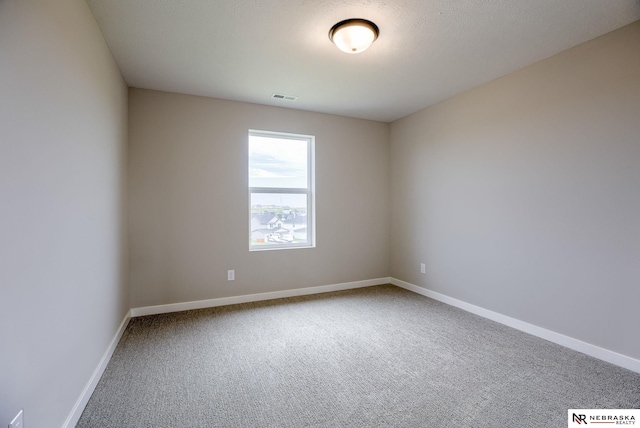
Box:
[390,22,640,358]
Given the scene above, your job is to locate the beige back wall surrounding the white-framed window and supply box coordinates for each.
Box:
[128,89,389,307]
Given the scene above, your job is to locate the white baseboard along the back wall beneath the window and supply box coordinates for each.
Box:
[131,277,391,317]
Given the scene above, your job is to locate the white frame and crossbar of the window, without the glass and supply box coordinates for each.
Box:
[247,129,316,251]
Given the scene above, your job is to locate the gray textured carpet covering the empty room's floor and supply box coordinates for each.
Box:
[77,286,640,428]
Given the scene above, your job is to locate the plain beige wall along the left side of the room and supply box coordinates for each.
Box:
[0,0,129,422]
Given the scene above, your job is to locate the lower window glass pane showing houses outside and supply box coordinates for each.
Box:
[251,193,308,247]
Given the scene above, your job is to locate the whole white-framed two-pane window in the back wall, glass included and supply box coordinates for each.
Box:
[249,130,315,250]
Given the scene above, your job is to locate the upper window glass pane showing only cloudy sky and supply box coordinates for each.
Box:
[249,135,308,189]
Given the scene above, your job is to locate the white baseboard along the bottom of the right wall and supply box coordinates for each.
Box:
[389,278,640,373]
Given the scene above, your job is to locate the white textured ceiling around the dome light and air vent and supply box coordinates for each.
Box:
[87,0,640,122]
